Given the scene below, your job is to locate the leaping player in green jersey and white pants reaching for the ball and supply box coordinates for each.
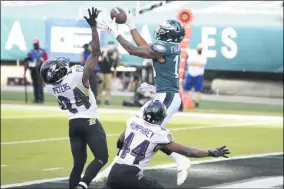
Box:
[98,14,191,185]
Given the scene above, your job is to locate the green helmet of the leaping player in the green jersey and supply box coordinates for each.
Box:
[154,20,185,43]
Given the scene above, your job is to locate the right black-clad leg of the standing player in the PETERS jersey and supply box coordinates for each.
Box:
[80,120,108,188]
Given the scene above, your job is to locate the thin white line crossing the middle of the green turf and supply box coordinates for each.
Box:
[1,121,276,145]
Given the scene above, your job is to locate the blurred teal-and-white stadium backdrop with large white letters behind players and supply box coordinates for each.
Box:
[1,1,283,105]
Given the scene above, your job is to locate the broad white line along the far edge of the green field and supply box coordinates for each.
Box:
[1,104,283,121]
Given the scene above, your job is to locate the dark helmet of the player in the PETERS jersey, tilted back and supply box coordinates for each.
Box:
[40,57,70,85]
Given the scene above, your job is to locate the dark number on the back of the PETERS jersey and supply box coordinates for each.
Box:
[57,87,91,114]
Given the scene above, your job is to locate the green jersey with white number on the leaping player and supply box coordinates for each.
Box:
[151,41,181,93]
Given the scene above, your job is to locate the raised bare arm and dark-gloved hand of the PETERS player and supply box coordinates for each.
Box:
[83,7,101,87]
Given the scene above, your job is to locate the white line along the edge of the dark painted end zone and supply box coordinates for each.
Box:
[1,152,283,188]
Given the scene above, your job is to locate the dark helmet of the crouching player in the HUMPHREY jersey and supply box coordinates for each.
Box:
[143,100,167,125]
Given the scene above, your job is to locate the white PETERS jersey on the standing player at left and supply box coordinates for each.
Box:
[47,65,97,119]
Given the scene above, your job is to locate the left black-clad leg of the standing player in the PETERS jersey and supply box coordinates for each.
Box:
[69,119,87,189]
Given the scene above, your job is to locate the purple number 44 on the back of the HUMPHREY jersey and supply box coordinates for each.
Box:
[120,133,150,164]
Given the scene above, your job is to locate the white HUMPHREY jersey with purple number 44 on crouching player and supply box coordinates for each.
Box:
[117,117,172,169]
